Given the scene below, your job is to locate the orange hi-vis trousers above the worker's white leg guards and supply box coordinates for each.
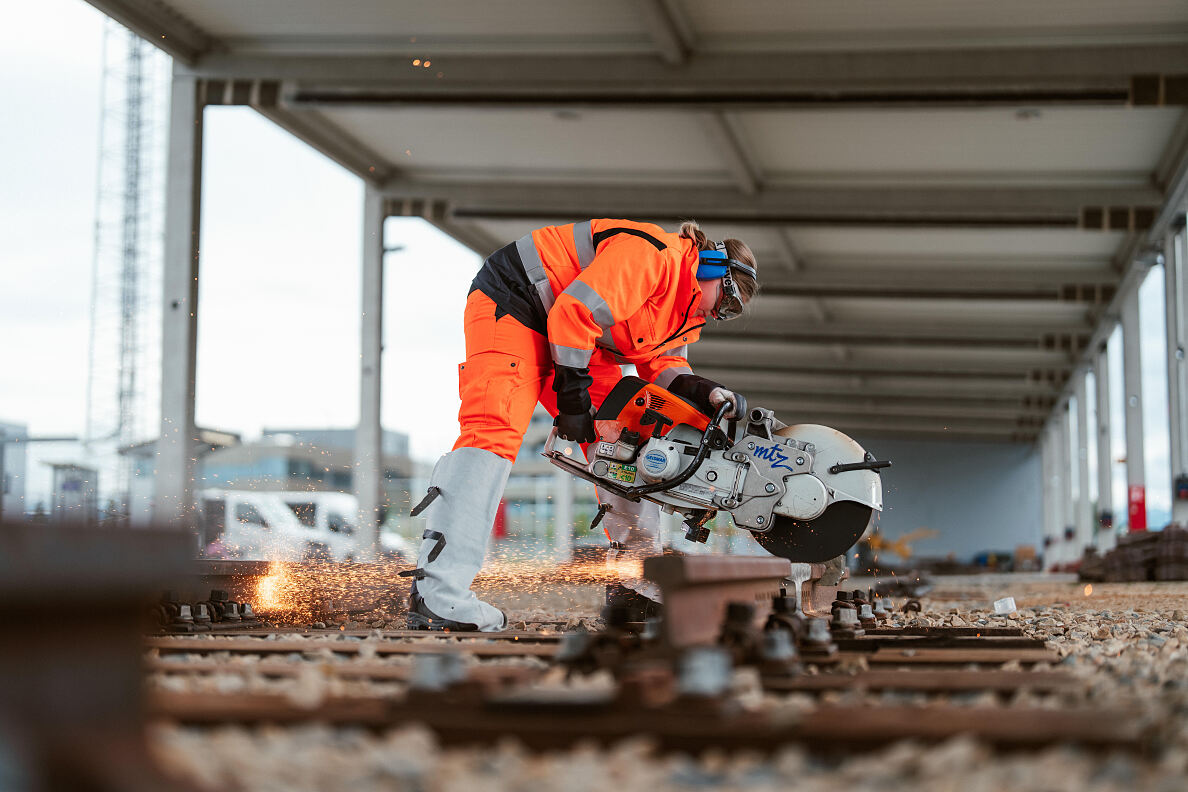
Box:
[454,290,623,462]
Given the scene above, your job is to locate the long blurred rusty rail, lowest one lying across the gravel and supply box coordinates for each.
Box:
[152,691,1152,754]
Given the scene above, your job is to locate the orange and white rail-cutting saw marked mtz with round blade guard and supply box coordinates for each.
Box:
[545,376,890,562]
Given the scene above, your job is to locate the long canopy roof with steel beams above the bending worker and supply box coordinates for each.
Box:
[90,0,1188,441]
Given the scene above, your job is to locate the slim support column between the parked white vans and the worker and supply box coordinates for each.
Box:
[354,185,385,562]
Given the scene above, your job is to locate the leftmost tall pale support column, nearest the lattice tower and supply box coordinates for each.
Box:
[153,66,203,527]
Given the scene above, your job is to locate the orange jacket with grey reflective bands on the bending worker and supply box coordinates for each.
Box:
[516,220,706,387]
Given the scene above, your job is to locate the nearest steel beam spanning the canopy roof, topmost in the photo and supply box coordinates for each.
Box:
[175,44,1188,109]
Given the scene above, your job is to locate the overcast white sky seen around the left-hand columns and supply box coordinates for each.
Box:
[0,0,480,498]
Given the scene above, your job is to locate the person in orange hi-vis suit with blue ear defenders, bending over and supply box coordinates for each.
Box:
[404,220,758,631]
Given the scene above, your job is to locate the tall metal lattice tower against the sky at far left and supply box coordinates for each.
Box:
[84,20,170,514]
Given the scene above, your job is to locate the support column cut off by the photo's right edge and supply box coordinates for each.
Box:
[1163,229,1188,525]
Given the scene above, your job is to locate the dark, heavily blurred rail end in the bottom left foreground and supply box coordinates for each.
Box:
[0,524,191,791]
